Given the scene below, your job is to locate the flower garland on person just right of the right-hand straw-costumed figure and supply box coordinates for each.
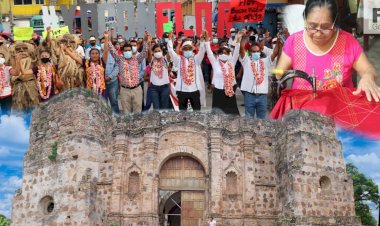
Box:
[86,60,106,95]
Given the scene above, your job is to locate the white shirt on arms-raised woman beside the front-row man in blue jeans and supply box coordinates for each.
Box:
[205,42,240,89]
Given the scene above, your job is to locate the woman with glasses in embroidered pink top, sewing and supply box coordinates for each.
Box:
[277,0,380,102]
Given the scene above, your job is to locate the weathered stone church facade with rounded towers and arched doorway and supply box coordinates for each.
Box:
[12,90,361,226]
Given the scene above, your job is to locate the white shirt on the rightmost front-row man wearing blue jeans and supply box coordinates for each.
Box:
[240,55,270,94]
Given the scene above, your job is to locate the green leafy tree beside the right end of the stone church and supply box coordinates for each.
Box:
[346,163,380,226]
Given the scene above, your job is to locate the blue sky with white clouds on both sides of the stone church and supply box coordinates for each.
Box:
[0,115,380,222]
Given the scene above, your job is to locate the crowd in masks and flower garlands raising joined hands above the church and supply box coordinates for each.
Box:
[0,27,288,118]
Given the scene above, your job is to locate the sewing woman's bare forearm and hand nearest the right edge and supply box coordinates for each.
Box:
[353,53,380,102]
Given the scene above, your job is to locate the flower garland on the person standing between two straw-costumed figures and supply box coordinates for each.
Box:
[37,64,53,100]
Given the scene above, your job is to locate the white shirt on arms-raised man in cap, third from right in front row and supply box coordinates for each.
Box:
[168,40,206,92]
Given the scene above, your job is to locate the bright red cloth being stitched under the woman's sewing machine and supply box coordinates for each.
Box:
[271,87,380,139]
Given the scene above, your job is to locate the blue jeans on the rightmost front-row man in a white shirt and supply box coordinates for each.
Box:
[244,92,268,119]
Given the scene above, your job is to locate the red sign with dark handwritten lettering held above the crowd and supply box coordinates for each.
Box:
[229,0,266,22]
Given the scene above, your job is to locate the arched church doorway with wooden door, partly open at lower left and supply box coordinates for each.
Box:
[159,156,206,226]
